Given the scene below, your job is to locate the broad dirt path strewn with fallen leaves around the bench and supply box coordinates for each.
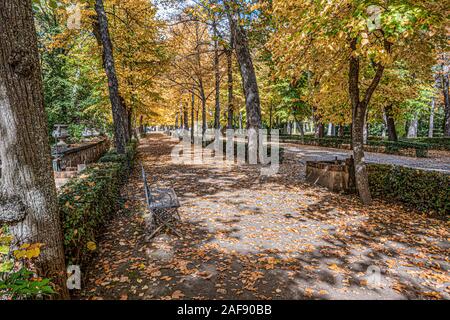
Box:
[81,135,450,299]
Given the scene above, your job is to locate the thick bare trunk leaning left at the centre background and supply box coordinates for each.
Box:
[225,3,261,129]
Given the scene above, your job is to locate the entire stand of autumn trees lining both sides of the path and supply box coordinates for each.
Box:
[0,0,450,297]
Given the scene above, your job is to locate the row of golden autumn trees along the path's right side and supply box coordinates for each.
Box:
[163,0,450,204]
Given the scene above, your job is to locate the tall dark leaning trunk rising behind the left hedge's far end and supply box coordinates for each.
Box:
[95,0,128,154]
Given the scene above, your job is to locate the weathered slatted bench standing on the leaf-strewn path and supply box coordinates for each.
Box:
[141,164,181,239]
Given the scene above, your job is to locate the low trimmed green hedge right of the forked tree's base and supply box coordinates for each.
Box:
[368,164,450,217]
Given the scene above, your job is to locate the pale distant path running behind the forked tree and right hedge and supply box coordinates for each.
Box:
[281,142,450,173]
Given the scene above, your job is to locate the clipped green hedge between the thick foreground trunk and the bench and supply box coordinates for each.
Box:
[58,141,137,264]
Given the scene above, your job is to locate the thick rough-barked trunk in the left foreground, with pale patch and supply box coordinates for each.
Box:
[0,0,69,299]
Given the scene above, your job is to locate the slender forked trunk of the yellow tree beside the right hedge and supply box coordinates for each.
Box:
[348,38,390,204]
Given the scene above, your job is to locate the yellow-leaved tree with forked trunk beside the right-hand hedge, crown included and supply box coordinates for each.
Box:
[272,0,446,204]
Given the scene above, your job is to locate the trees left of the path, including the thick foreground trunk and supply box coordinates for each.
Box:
[0,0,166,298]
